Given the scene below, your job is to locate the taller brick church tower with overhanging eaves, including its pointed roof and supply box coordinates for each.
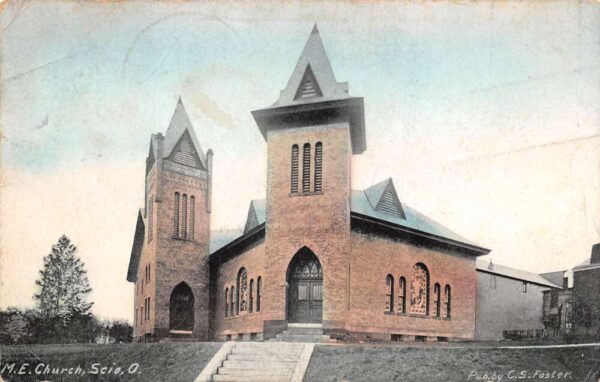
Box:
[252,25,366,337]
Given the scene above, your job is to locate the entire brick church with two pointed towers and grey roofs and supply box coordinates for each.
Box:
[127,26,489,340]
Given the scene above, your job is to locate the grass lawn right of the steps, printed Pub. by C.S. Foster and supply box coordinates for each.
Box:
[304,344,600,382]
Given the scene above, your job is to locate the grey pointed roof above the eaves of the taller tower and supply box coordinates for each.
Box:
[274,24,350,106]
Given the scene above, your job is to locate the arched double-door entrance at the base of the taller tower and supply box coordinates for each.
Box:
[286,247,323,323]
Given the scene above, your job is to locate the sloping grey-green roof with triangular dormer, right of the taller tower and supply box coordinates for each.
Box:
[350,178,480,248]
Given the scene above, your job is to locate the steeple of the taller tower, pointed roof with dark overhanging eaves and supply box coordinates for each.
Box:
[252,24,367,154]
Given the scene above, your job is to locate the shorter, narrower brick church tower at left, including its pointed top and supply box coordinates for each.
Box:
[127,99,212,340]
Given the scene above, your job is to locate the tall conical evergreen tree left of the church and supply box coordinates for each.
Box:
[34,235,93,327]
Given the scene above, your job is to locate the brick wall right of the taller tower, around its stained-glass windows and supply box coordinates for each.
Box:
[350,232,477,339]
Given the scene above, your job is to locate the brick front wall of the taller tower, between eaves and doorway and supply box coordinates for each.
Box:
[263,123,352,336]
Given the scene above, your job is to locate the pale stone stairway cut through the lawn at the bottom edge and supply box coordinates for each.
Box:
[207,342,314,382]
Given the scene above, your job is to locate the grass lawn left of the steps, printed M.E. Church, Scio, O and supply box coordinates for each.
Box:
[0,342,222,382]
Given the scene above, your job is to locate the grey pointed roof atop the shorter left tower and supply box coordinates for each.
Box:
[150,98,207,169]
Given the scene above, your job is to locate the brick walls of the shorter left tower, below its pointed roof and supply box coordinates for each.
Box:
[134,161,210,339]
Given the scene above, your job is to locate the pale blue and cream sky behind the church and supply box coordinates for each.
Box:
[0,1,600,317]
